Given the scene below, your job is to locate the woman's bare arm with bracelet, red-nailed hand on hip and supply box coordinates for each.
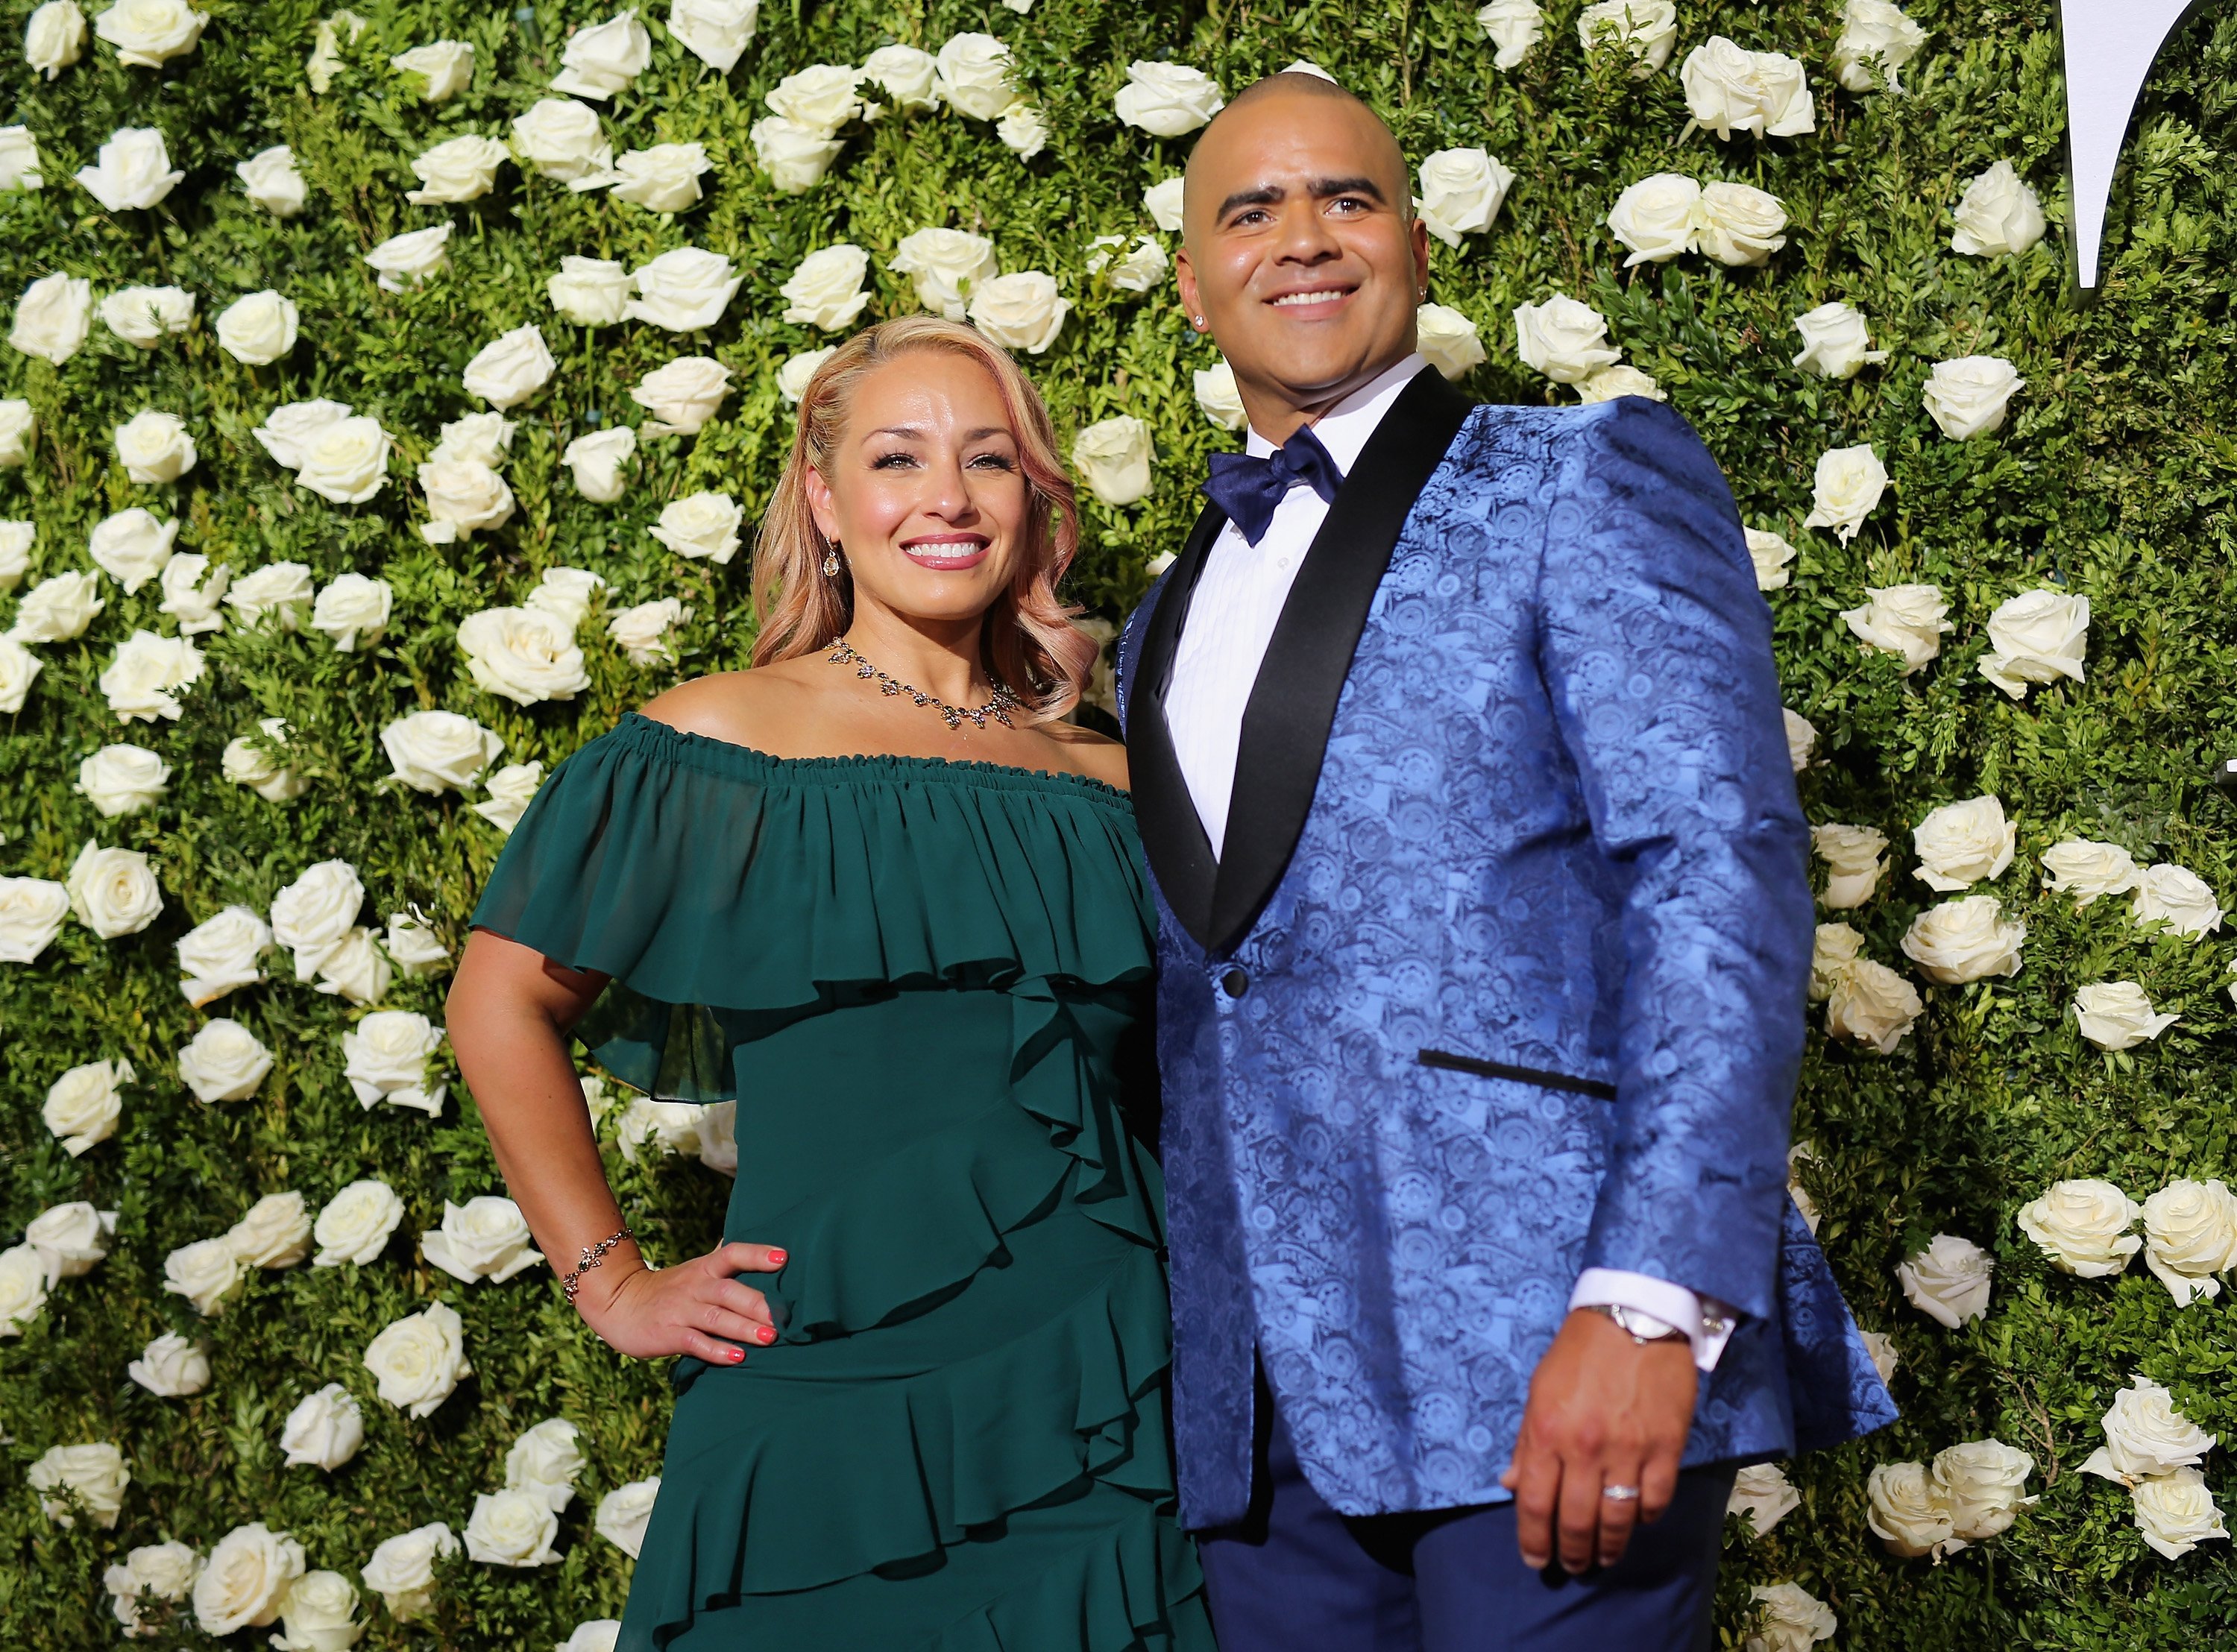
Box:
[445,930,785,1366]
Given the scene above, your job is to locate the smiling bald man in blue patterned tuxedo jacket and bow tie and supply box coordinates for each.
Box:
[1118,74,1895,1652]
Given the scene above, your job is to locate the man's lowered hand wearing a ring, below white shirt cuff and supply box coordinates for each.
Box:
[1499,1308,1700,1574]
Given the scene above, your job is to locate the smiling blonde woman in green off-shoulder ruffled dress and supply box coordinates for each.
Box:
[450,318,1212,1652]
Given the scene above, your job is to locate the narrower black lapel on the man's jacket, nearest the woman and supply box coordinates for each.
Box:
[1125,505,1226,945]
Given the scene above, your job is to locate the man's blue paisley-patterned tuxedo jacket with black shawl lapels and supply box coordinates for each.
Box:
[1118,369,1895,1529]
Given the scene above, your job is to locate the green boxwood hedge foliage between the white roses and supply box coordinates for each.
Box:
[0,0,2237,1650]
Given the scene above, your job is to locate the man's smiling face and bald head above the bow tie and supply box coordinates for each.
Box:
[1179,87,1429,441]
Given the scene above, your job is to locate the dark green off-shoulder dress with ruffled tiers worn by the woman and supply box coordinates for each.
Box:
[470,711,1212,1652]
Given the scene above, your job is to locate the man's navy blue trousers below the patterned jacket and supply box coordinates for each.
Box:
[1197,1384,1738,1652]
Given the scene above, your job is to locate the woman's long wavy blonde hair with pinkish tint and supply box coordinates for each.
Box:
[752,315,1098,722]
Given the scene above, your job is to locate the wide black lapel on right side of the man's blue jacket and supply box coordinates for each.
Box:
[1217,367,1474,952]
